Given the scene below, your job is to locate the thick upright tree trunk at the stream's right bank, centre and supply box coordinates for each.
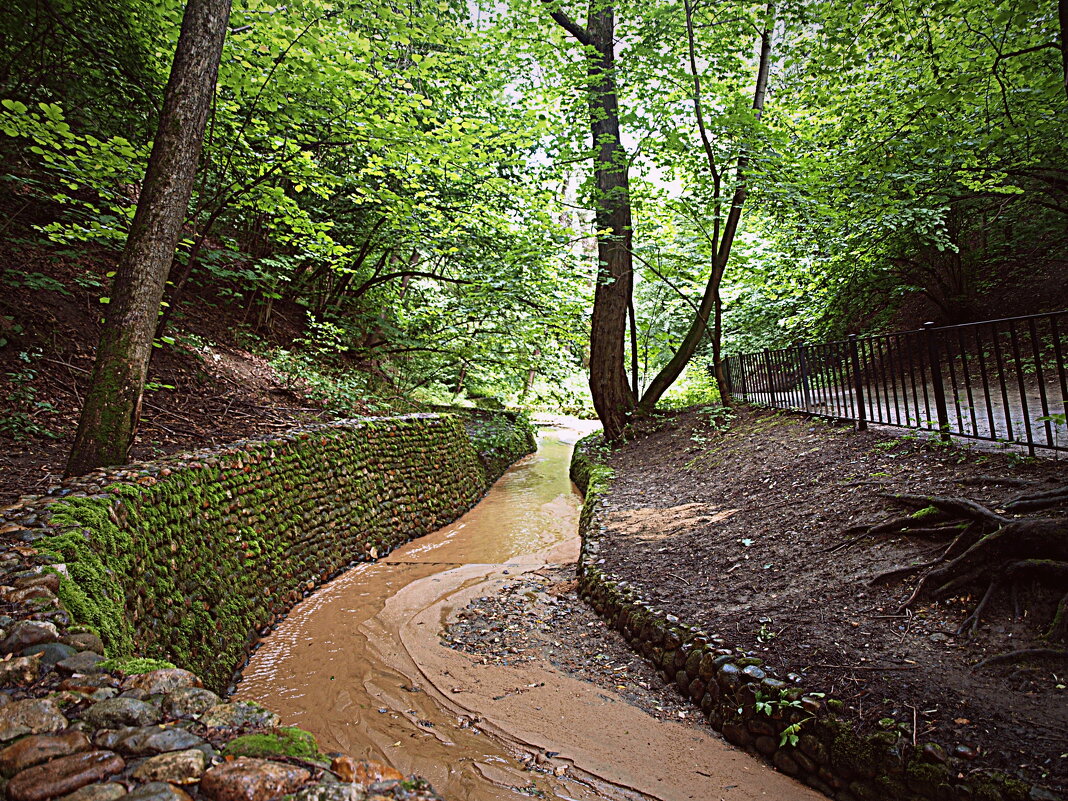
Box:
[550,2,637,442]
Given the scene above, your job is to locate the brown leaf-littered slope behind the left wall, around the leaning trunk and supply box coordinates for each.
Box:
[0,234,380,505]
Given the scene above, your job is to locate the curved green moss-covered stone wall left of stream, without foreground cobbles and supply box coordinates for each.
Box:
[5,414,533,690]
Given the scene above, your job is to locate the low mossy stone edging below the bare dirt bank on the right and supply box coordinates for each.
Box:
[571,434,1057,801]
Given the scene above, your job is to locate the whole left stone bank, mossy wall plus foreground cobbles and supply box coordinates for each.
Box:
[0,414,533,801]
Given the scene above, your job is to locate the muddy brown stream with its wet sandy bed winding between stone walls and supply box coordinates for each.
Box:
[235,427,822,801]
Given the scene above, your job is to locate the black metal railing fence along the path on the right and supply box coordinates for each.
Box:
[726,311,1068,456]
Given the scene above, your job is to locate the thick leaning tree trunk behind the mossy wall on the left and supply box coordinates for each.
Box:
[66,0,230,475]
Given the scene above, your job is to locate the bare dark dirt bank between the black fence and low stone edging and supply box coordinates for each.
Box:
[600,409,1068,790]
